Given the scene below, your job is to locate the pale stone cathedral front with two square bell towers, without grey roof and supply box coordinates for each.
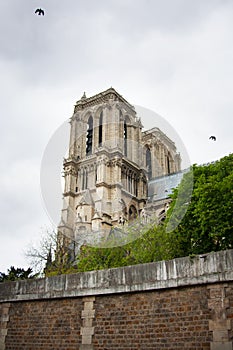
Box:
[58,88,181,246]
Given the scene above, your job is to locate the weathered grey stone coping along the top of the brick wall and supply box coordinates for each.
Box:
[0,250,233,302]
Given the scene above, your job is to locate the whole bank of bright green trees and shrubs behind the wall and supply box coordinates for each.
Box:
[77,155,233,271]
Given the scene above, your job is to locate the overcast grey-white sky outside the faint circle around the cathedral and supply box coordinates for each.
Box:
[0,0,233,272]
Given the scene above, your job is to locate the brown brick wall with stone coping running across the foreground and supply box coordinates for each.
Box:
[0,250,233,350]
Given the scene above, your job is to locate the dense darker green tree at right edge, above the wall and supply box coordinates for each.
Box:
[166,154,233,257]
